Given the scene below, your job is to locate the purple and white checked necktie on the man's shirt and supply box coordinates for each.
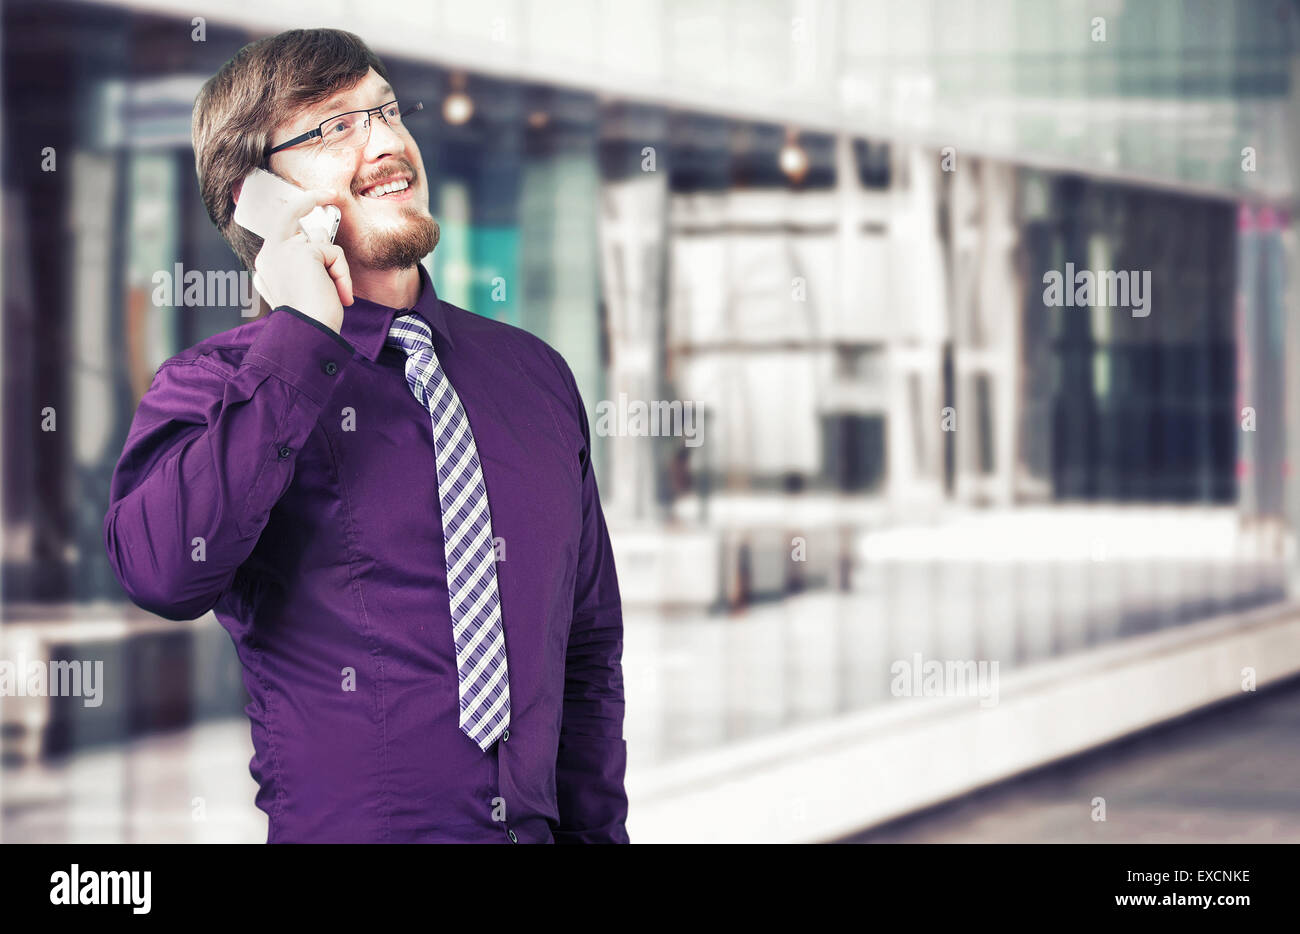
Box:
[387,315,510,752]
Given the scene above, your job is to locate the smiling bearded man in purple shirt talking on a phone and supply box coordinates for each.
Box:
[104,30,628,843]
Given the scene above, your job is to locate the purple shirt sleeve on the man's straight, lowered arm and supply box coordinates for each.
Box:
[554,353,629,843]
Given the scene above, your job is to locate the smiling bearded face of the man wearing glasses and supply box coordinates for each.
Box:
[270,68,439,269]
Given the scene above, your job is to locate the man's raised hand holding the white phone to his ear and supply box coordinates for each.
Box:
[252,189,352,333]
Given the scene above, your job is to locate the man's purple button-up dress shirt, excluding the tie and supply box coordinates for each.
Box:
[104,267,628,843]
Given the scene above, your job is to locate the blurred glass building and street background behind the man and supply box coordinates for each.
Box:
[0,0,1300,843]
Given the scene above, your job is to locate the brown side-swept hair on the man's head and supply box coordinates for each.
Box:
[191,29,390,272]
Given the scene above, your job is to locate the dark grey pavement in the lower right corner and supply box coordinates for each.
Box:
[837,678,1300,843]
